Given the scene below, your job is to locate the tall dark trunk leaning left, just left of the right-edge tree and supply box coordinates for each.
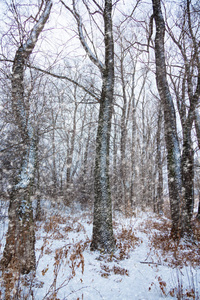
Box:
[152,0,182,238]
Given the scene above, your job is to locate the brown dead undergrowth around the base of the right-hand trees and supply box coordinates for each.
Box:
[140,218,200,267]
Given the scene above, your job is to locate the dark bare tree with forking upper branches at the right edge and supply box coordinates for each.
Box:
[166,0,200,235]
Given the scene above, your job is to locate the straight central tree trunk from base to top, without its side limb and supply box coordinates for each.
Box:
[91,0,115,252]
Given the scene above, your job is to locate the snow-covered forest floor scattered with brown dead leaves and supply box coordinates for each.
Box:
[0,201,200,300]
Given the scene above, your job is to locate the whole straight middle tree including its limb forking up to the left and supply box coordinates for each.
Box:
[61,0,115,252]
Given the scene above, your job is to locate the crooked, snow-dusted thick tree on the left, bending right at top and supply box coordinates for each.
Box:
[1,0,52,273]
